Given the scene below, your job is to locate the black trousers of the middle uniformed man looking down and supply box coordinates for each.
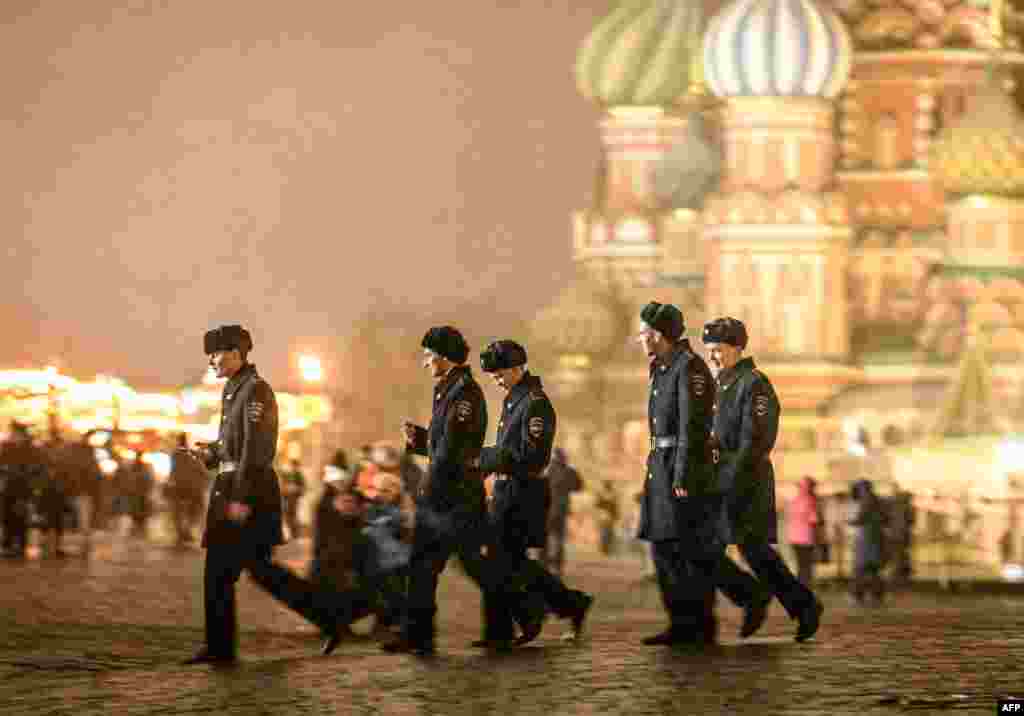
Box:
[494,530,583,624]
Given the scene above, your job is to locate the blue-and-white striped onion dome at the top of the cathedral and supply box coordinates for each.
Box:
[703,0,853,97]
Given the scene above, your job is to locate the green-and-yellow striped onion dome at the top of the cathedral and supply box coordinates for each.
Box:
[575,0,702,107]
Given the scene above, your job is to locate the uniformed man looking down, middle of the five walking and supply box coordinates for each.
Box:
[479,340,594,645]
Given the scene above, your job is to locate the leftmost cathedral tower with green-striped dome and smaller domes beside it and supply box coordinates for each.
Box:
[531,0,719,476]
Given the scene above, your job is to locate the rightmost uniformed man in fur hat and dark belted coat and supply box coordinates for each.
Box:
[703,318,822,641]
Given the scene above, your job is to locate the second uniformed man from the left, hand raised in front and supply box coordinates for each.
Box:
[383,326,505,656]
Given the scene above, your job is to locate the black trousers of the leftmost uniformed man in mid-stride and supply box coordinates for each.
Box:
[203,543,367,657]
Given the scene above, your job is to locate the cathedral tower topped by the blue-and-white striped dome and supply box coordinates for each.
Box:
[703,0,852,411]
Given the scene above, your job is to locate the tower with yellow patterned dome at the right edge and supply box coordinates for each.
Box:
[916,68,1024,419]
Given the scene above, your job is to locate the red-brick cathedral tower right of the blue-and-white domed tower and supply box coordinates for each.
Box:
[835,0,1022,356]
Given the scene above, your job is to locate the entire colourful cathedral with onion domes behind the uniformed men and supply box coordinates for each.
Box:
[532,0,1024,510]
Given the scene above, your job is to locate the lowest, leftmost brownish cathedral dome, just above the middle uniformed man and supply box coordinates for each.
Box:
[529,280,626,355]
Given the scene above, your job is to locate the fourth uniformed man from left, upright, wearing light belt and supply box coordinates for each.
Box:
[638,302,745,645]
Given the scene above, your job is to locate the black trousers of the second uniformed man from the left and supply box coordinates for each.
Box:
[403,506,513,644]
